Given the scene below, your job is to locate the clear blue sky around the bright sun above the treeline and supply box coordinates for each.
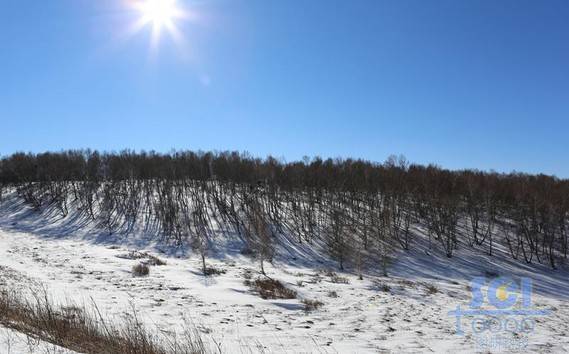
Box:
[0,0,569,177]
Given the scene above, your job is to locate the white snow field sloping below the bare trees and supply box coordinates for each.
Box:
[0,195,569,354]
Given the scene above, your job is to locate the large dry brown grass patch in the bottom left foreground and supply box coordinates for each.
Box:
[0,291,206,354]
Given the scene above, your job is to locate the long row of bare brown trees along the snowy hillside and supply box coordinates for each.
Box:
[0,150,569,273]
